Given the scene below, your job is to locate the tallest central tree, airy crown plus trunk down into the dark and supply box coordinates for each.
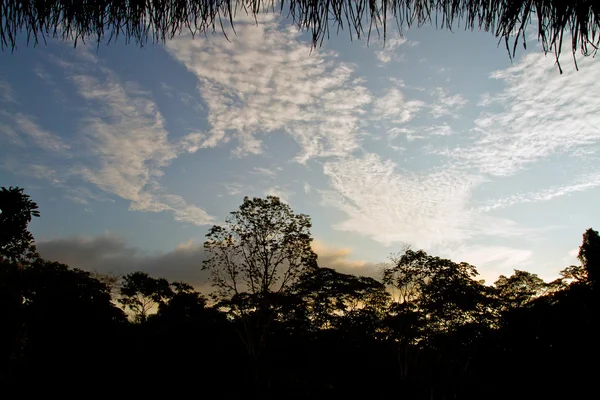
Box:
[203,196,317,394]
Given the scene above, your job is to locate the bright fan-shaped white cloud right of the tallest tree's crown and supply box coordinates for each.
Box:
[324,154,479,248]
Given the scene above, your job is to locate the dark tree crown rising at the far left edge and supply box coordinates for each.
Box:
[0,186,40,262]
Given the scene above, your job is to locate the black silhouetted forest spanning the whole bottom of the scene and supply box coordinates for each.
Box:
[0,187,600,399]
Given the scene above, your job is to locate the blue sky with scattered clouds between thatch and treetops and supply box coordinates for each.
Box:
[0,16,600,283]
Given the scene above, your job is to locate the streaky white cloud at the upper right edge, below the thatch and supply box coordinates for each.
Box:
[448,53,600,176]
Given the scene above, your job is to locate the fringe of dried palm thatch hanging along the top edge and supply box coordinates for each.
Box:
[0,0,600,70]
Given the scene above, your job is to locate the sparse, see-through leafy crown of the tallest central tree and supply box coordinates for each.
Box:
[203,196,317,299]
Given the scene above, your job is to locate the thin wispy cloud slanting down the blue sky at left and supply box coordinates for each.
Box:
[58,50,214,225]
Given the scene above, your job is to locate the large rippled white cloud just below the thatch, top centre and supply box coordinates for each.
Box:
[167,15,371,162]
